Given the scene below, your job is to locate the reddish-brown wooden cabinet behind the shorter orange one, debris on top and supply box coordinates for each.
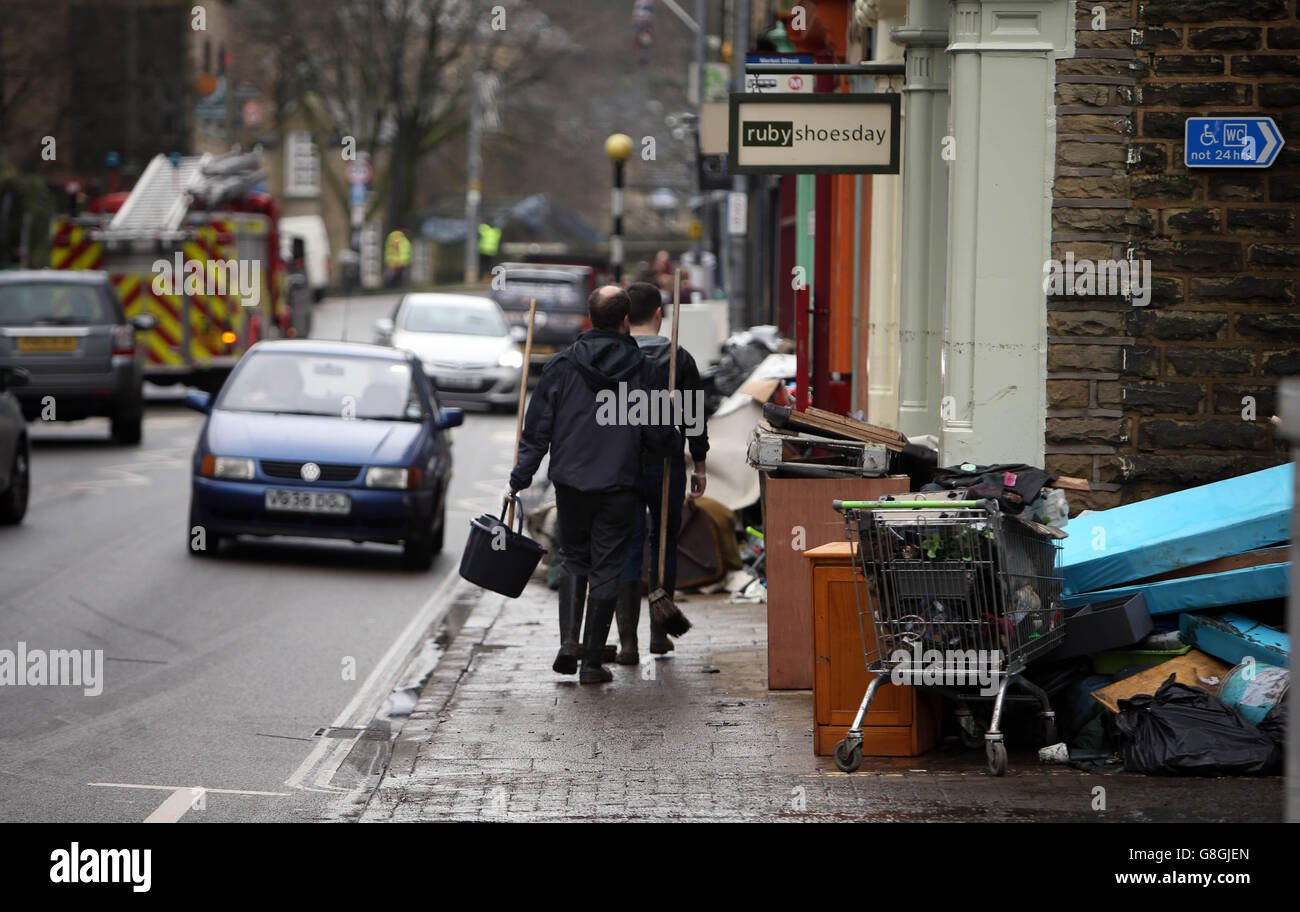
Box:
[762,475,910,690]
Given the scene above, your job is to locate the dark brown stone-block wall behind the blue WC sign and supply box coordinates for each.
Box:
[1045,0,1300,508]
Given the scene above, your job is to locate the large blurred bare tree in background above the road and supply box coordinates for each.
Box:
[241,0,572,232]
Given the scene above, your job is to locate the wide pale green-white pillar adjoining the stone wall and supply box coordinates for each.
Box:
[940,0,1075,465]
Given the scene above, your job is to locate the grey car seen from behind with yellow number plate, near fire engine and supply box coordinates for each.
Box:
[0,269,157,444]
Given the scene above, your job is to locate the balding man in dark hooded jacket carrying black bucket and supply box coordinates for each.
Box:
[510,286,672,683]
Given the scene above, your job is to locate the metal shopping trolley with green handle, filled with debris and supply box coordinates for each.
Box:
[833,491,1065,776]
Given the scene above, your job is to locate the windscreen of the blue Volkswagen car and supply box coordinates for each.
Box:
[217,352,424,421]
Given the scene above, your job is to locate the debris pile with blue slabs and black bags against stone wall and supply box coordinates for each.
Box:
[1047,465,1295,776]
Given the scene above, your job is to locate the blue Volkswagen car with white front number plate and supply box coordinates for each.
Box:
[186,339,463,569]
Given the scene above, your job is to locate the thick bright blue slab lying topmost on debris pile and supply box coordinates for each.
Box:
[1061,465,1295,594]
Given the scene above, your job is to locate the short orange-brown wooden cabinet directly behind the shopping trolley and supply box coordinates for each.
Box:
[805,542,940,757]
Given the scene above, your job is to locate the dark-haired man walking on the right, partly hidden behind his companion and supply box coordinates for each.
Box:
[615,282,709,665]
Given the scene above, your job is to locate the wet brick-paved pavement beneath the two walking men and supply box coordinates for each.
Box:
[350,582,1283,821]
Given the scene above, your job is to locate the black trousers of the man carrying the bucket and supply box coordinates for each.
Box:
[555,485,640,602]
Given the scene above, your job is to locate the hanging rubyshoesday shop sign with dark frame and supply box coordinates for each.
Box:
[728,92,898,174]
